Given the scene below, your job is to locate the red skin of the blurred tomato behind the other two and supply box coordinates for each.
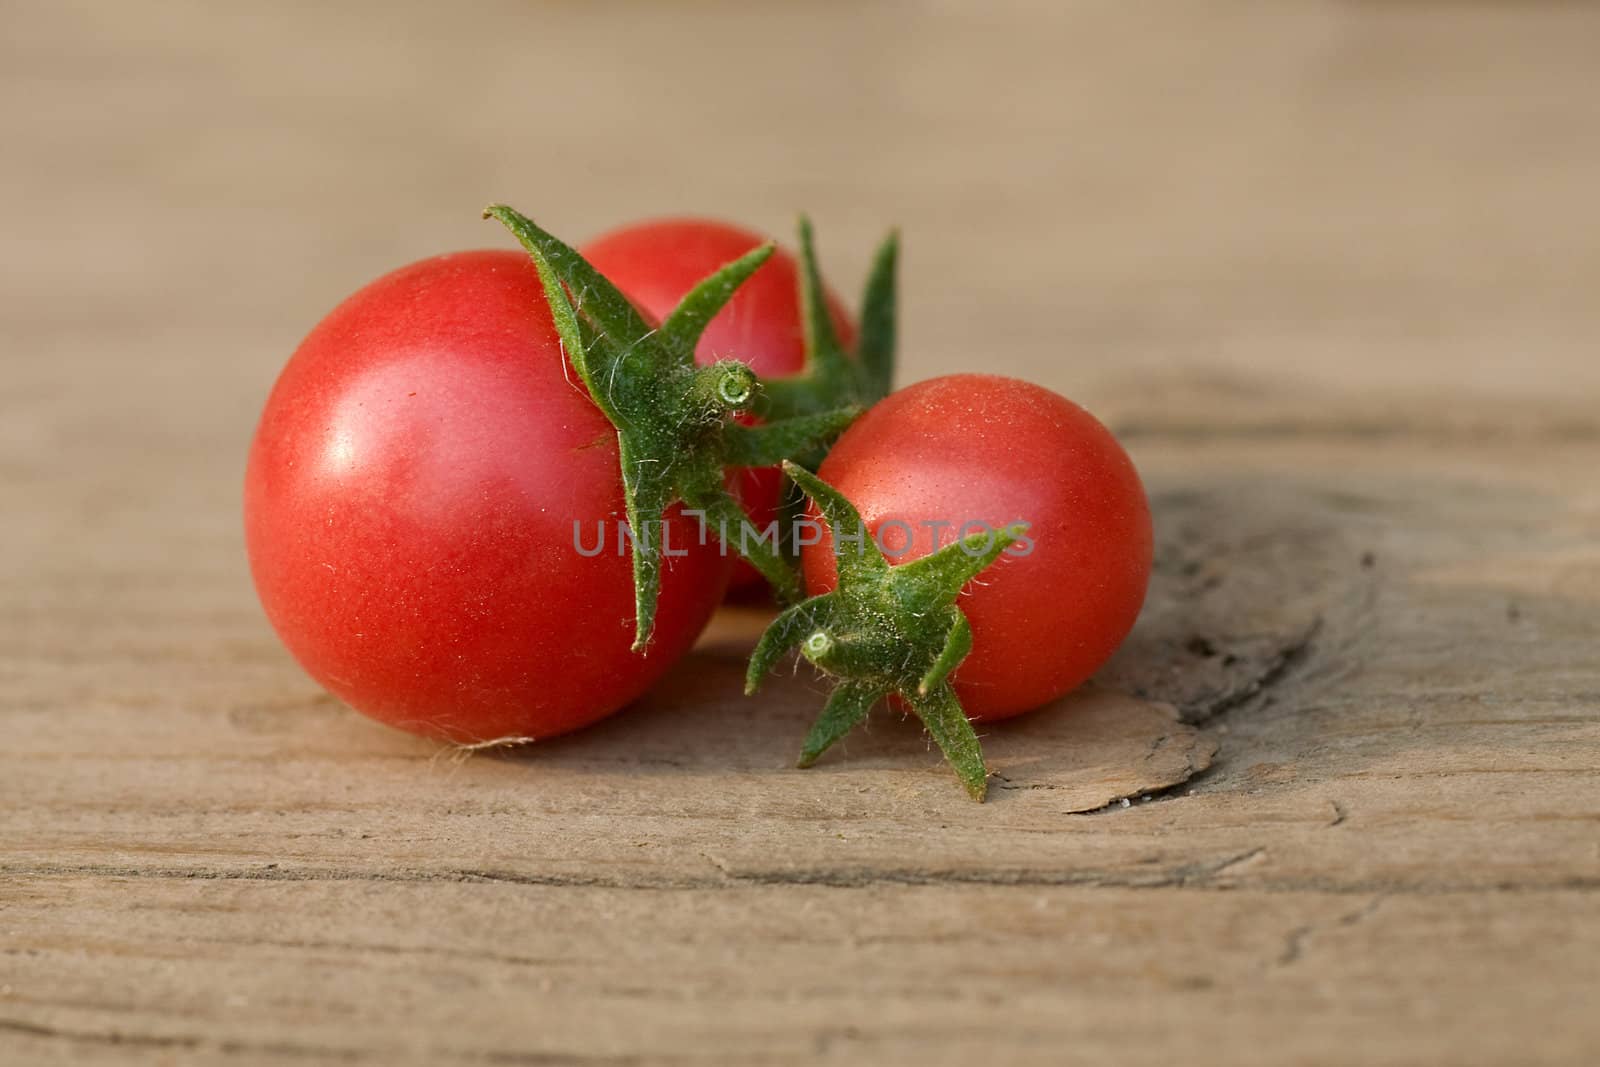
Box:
[578,219,856,592]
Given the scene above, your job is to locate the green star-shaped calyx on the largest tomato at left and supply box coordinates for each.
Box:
[483,205,861,651]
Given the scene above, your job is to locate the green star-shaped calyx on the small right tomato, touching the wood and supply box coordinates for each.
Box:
[744,462,1027,800]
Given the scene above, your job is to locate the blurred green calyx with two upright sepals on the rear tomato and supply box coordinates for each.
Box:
[757,216,899,419]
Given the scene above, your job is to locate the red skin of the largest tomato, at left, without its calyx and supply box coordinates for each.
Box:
[245,251,731,742]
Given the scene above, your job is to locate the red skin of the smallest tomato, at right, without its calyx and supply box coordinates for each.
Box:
[802,374,1152,721]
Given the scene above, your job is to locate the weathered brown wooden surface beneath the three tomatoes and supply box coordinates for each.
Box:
[0,3,1600,1064]
